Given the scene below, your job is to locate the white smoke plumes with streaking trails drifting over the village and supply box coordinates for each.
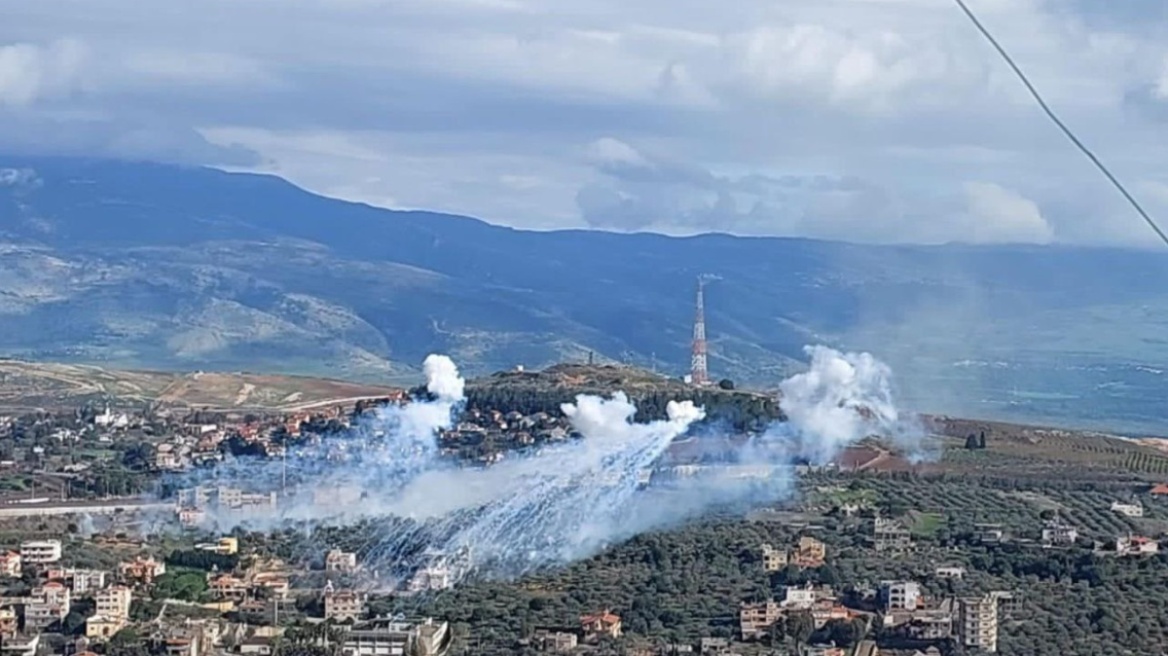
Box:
[169,347,919,584]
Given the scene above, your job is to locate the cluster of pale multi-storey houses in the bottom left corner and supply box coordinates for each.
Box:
[0,537,451,656]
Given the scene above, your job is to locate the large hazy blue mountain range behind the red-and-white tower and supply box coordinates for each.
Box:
[0,156,1168,427]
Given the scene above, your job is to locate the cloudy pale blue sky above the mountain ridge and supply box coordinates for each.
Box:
[0,0,1168,246]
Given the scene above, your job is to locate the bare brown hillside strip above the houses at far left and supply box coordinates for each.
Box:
[0,361,396,411]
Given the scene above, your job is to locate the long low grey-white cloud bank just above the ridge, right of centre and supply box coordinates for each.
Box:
[576,138,1054,244]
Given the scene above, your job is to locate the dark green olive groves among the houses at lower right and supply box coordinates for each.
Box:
[357,462,1168,656]
